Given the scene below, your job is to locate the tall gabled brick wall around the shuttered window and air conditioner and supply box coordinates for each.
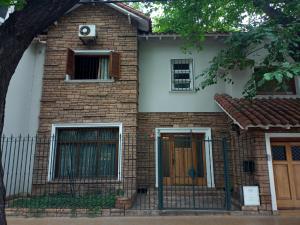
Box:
[33,5,138,197]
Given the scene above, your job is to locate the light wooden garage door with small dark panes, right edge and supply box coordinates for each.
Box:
[271,142,300,209]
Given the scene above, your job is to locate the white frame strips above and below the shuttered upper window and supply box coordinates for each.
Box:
[65,50,115,83]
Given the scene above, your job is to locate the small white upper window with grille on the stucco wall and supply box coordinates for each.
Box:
[171,59,194,91]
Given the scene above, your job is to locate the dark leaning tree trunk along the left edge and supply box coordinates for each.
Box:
[0,0,79,225]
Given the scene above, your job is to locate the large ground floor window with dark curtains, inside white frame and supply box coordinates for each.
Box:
[55,127,119,178]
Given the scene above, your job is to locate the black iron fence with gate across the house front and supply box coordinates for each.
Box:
[0,134,256,216]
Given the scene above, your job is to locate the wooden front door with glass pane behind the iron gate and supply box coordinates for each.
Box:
[161,134,206,185]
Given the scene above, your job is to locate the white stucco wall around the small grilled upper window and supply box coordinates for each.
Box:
[139,37,249,112]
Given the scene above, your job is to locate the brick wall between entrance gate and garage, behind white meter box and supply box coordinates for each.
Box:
[229,124,300,214]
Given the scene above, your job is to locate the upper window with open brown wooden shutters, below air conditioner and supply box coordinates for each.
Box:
[66,49,120,80]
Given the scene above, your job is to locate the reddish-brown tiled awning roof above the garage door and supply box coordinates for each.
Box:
[215,94,300,129]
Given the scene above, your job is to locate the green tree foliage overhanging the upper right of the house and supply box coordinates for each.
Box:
[158,0,300,97]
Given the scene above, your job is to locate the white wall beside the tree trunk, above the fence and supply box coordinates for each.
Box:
[3,43,45,136]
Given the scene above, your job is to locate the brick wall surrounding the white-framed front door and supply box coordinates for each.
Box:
[137,113,229,187]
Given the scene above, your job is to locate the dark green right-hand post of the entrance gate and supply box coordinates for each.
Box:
[222,138,231,210]
